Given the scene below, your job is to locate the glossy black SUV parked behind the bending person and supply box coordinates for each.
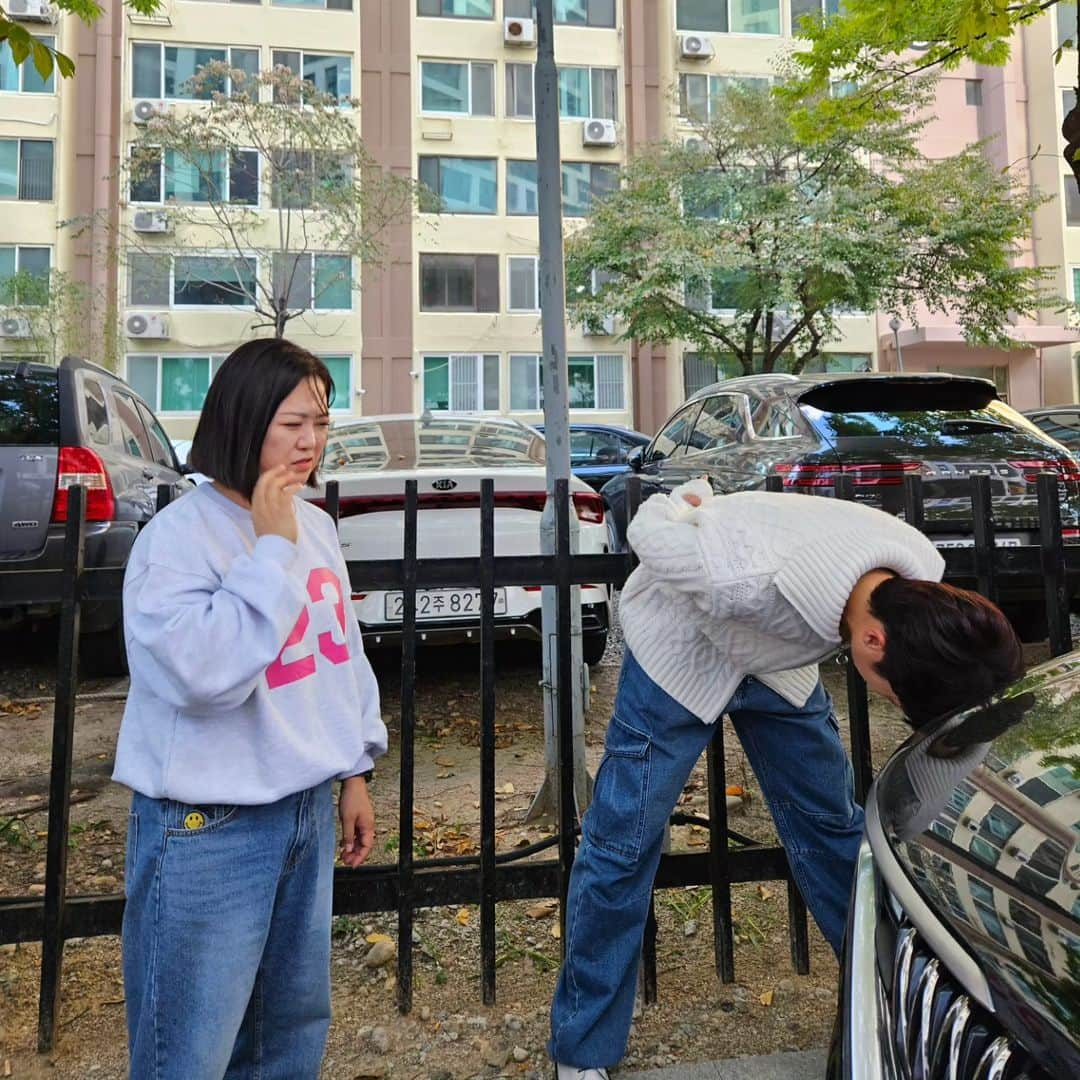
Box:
[602,373,1080,639]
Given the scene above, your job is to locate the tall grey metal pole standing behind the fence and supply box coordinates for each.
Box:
[527,0,589,825]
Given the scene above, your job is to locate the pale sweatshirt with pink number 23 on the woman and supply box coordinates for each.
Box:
[112,484,387,805]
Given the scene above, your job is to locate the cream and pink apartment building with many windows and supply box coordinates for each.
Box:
[0,0,1080,435]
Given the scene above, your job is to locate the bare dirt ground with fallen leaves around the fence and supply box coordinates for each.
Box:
[0,642,1045,1080]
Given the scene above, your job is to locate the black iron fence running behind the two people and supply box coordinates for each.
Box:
[0,473,1080,1050]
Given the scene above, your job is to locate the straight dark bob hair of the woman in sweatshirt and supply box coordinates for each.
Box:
[188,338,334,499]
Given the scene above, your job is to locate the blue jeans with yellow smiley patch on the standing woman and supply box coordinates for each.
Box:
[123,781,337,1080]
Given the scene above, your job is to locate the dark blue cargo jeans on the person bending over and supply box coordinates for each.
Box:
[548,651,863,1068]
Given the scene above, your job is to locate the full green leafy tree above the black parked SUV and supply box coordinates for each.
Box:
[566,81,1061,374]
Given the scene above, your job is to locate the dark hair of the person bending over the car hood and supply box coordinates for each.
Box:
[869,577,1024,727]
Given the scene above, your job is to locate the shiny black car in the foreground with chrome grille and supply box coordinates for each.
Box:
[828,651,1080,1080]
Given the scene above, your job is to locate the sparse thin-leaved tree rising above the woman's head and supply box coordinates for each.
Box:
[99,62,417,337]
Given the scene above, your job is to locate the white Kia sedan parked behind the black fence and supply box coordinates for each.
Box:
[315,413,611,664]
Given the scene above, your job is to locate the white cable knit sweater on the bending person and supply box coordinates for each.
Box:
[620,480,945,724]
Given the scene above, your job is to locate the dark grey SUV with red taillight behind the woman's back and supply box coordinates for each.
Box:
[0,356,191,675]
